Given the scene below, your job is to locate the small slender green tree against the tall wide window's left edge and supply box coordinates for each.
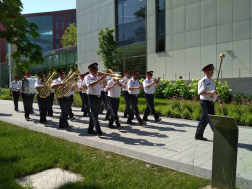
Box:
[96,27,121,69]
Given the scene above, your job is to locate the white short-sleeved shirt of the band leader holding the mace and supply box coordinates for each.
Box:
[198,76,217,101]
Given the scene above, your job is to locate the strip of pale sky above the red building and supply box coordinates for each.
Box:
[21,0,76,14]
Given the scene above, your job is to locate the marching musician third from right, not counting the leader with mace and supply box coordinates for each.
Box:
[121,70,134,121]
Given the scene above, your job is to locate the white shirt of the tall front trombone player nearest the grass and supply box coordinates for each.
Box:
[84,74,103,96]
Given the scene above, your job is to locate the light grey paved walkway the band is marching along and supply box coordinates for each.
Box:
[0,100,252,188]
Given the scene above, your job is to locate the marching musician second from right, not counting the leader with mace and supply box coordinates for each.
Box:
[127,71,146,126]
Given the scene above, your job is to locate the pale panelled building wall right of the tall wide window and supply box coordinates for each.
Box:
[147,0,252,80]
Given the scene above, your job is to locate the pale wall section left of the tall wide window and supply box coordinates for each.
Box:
[76,0,115,73]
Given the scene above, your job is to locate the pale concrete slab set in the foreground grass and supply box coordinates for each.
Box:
[16,168,83,189]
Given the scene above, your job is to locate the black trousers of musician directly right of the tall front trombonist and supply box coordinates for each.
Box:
[108,97,121,128]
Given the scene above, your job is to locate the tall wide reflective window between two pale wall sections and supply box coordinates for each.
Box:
[116,0,146,75]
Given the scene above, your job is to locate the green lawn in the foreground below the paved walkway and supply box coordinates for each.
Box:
[0,121,209,189]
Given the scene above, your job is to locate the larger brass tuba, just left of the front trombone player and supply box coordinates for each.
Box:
[55,65,81,98]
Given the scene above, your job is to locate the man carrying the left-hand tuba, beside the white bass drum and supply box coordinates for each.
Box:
[35,72,49,126]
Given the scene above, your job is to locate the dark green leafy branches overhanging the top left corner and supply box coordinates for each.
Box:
[0,0,44,66]
